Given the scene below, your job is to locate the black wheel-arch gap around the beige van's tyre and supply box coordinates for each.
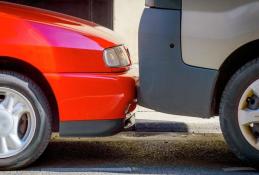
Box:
[213,40,259,115]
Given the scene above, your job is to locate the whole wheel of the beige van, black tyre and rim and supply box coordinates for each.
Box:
[219,59,259,165]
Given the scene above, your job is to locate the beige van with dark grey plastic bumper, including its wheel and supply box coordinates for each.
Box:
[138,0,259,164]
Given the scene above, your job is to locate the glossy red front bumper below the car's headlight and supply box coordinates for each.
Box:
[44,73,137,122]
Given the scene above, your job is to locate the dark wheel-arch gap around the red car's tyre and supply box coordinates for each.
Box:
[0,56,59,132]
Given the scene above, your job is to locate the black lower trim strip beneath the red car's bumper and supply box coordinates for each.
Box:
[60,119,124,137]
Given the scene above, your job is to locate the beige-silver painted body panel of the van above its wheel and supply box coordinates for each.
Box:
[182,0,259,69]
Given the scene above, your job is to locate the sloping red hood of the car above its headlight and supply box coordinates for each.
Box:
[0,2,122,47]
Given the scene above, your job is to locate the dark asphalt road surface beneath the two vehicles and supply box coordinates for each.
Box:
[0,133,259,175]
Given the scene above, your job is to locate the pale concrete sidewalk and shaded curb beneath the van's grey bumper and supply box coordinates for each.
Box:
[136,107,221,133]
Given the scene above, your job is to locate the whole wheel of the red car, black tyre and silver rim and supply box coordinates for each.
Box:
[0,71,51,170]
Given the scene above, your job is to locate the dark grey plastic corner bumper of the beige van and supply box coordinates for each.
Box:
[138,8,218,117]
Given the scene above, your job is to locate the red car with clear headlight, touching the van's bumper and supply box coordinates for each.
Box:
[0,2,136,169]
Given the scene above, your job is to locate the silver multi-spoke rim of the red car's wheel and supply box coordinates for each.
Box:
[0,87,36,158]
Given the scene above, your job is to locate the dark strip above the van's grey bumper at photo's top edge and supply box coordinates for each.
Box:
[146,0,182,9]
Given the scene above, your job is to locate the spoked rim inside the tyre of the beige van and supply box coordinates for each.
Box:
[238,80,259,150]
